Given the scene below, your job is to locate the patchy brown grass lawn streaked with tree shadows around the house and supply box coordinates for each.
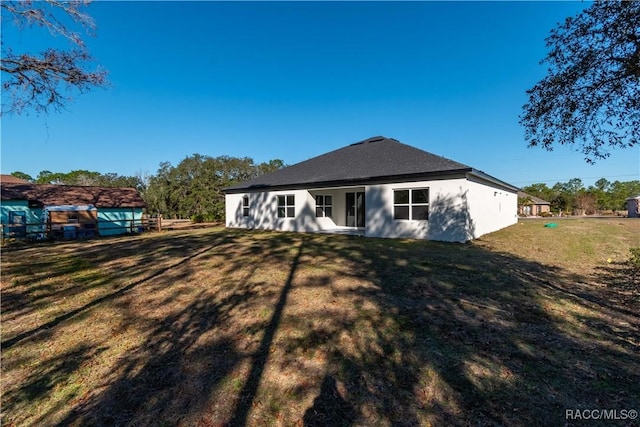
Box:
[2,220,640,426]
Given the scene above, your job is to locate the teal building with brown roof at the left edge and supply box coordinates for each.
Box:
[0,181,145,239]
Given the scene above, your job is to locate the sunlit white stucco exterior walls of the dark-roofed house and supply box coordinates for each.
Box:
[225,177,518,242]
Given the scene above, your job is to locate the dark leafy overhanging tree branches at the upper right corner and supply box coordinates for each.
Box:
[520,1,640,163]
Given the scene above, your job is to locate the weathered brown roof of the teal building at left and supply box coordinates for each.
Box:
[1,183,146,208]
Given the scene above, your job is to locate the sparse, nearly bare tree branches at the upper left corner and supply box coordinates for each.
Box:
[0,0,106,114]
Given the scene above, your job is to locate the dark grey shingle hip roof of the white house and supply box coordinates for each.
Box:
[225,136,473,192]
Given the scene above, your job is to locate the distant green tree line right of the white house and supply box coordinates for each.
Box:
[522,178,640,215]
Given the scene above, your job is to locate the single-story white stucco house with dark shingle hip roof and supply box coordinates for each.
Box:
[225,136,518,242]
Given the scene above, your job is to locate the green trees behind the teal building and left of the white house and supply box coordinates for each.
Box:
[11,154,284,221]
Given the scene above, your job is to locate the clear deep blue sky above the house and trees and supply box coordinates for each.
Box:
[1,1,640,186]
